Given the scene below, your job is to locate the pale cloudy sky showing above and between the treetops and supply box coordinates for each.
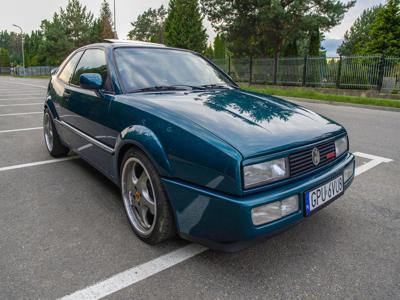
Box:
[0,0,385,48]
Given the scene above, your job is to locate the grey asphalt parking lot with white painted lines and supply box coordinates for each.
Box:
[0,76,400,299]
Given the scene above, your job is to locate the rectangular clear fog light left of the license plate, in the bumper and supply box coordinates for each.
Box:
[251,195,299,225]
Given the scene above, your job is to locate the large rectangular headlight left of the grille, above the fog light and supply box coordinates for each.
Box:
[243,158,289,188]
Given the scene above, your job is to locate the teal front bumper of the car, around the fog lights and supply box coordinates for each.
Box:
[163,153,354,251]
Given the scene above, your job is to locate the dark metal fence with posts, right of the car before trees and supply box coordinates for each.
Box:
[214,56,400,93]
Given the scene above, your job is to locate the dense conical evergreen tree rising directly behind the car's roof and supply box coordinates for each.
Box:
[165,0,207,53]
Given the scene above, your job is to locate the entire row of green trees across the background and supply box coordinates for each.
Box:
[0,0,400,68]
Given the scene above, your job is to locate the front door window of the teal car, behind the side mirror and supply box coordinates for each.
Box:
[71,49,111,91]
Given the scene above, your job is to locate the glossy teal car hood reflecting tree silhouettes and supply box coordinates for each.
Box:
[123,89,345,158]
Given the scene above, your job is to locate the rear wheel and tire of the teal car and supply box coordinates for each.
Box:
[43,108,69,157]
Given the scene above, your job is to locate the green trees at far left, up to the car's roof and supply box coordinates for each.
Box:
[0,0,117,66]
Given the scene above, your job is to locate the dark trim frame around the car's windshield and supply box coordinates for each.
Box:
[112,45,239,94]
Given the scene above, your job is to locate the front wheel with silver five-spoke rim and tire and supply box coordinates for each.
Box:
[120,148,176,245]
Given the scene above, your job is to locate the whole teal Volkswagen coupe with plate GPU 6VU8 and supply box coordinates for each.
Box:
[43,40,354,251]
